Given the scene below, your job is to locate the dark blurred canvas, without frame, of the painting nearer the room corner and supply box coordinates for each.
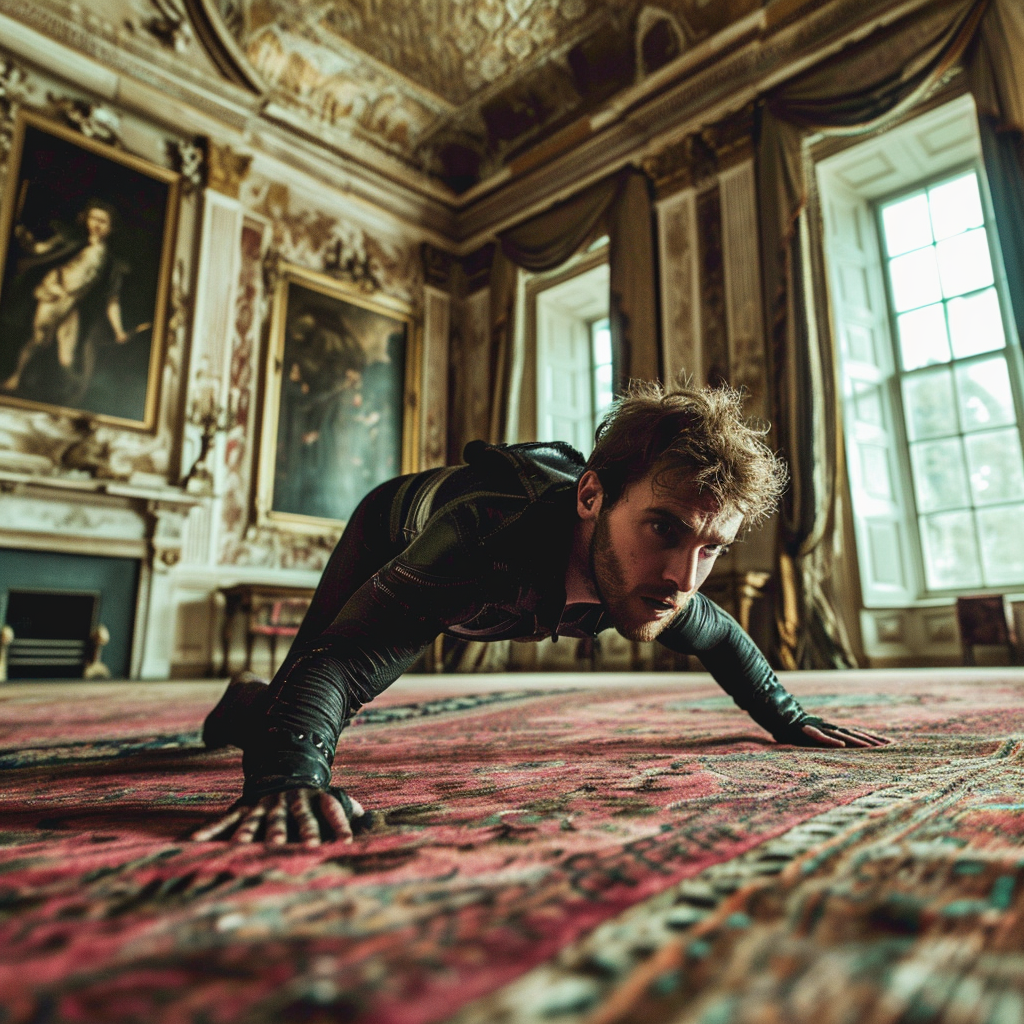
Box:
[270,281,408,520]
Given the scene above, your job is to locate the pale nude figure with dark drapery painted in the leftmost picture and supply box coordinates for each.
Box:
[0,200,129,404]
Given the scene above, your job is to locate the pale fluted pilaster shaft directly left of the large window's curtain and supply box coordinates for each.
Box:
[719,161,767,417]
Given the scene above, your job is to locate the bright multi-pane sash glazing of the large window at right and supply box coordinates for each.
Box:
[878,170,1024,591]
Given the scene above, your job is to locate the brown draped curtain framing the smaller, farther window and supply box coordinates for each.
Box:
[479,167,658,442]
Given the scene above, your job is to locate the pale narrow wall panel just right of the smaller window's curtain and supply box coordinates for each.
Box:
[657,188,705,384]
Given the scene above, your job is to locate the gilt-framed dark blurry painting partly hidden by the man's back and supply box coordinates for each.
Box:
[256,266,420,532]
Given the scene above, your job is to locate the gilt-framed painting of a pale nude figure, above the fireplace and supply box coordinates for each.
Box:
[0,112,179,430]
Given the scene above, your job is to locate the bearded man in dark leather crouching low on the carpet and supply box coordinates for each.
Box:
[195,384,887,845]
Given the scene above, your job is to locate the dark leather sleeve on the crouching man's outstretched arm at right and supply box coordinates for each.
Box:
[658,593,810,743]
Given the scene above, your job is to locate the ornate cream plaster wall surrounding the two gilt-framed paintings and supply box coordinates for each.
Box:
[0,8,436,678]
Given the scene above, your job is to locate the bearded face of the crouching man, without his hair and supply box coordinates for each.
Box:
[589,474,743,640]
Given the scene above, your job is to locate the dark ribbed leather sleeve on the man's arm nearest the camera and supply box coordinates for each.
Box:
[242,509,491,800]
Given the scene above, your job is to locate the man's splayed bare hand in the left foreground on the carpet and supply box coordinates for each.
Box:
[191,788,364,847]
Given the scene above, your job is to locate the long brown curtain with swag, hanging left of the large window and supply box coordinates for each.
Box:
[756,0,991,669]
